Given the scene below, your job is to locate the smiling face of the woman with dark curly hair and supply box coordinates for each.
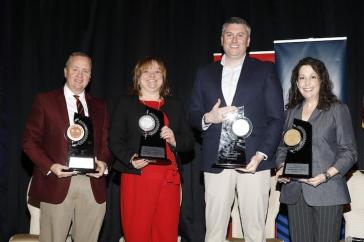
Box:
[297,65,321,101]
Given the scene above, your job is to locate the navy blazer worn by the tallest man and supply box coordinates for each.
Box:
[189,56,284,173]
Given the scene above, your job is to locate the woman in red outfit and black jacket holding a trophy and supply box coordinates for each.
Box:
[109,57,194,242]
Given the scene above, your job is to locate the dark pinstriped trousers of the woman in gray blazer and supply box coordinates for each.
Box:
[287,194,343,242]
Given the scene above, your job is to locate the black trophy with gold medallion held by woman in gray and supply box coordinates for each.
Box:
[282,119,312,178]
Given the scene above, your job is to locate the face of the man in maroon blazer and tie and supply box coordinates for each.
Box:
[64,56,91,94]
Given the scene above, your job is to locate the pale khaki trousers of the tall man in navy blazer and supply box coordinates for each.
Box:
[204,169,270,242]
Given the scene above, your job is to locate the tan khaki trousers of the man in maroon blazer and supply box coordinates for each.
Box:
[39,175,106,242]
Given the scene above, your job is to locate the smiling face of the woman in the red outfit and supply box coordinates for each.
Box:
[139,61,163,96]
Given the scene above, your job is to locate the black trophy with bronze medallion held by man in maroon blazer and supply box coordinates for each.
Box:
[64,113,96,174]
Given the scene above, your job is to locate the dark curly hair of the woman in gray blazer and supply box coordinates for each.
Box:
[286,57,339,110]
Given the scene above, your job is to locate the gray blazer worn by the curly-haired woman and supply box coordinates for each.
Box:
[276,103,357,206]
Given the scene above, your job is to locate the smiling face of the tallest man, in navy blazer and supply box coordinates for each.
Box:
[221,24,250,59]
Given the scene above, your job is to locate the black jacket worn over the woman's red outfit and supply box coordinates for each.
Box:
[109,96,194,174]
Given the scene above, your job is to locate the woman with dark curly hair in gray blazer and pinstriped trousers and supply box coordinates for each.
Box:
[276,57,357,242]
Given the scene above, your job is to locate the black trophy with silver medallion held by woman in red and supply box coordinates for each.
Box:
[138,106,168,162]
